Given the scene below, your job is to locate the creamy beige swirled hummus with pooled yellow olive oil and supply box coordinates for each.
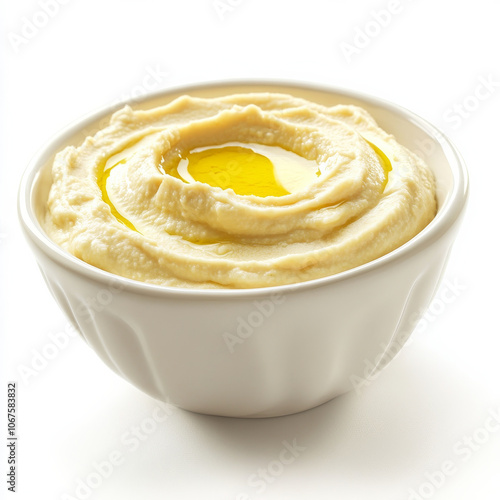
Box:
[44,93,436,288]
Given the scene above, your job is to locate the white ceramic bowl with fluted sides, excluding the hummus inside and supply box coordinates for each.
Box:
[19,81,468,417]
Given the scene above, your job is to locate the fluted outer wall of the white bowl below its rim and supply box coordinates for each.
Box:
[27,232,449,417]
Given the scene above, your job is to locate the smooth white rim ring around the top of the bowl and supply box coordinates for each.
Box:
[17,78,469,299]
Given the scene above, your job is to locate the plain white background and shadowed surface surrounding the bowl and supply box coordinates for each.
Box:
[0,0,500,500]
